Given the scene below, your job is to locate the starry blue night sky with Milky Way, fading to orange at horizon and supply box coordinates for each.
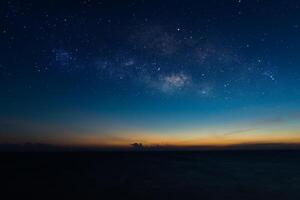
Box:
[0,0,300,147]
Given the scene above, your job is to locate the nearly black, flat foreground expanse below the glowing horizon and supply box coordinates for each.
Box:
[0,151,300,200]
